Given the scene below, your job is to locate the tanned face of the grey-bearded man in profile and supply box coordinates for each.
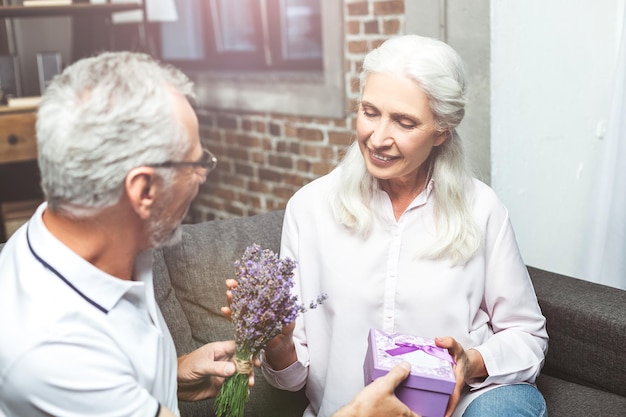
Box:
[148,94,208,247]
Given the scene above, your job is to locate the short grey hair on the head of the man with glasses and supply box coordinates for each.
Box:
[37,52,194,216]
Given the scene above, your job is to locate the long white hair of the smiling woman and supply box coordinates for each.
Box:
[332,35,482,265]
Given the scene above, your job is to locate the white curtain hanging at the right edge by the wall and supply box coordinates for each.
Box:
[584,4,626,290]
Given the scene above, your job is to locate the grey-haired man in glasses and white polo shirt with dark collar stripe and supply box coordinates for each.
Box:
[0,52,420,417]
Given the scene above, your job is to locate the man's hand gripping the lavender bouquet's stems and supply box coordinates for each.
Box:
[178,340,258,401]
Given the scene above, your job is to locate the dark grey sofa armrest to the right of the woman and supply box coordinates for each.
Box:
[528,267,626,396]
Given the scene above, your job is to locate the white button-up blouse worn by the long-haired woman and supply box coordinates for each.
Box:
[263,169,548,417]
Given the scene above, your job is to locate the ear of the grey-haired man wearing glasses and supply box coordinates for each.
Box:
[124,166,157,220]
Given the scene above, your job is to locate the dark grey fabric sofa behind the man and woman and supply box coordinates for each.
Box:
[0,211,626,417]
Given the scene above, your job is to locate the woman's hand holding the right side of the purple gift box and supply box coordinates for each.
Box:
[435,336,489,417]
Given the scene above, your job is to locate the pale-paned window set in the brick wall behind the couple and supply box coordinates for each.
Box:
[161,0,323,71]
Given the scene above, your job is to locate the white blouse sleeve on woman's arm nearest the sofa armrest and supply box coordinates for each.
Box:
[470,199,548,388]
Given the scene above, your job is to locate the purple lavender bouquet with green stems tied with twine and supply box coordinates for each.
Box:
[215,244,326,417]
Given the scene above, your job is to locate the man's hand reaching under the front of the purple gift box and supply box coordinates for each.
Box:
[332,362,419,417]
